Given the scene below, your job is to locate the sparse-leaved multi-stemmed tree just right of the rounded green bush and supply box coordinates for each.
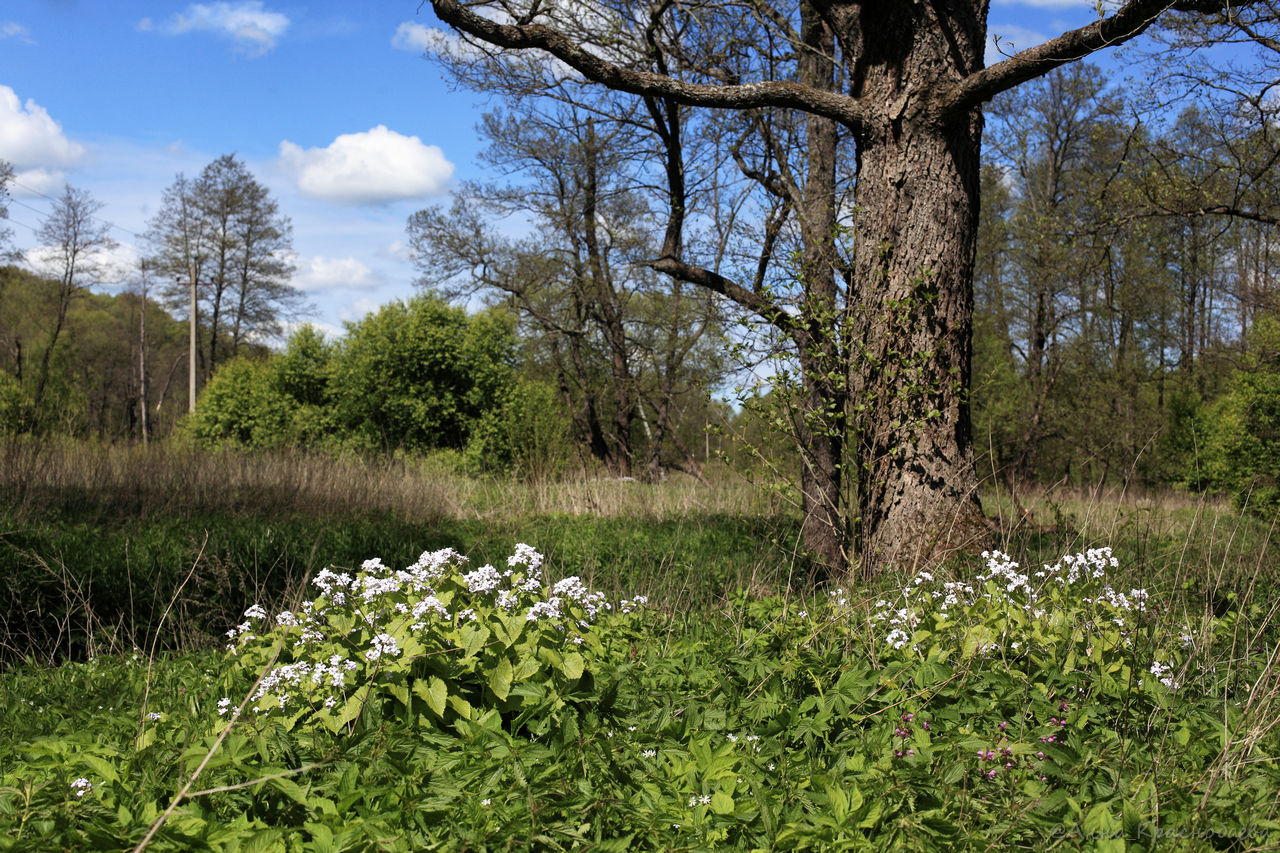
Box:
[408,99,719,476]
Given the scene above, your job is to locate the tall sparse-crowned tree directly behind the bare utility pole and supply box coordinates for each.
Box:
[147,154,302,378]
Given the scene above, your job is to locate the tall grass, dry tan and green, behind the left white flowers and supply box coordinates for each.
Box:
[0,441,796,663]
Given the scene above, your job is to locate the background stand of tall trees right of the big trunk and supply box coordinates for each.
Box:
[974,64,1280,508]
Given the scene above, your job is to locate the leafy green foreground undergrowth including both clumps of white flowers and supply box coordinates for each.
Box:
[0,540,1280,850]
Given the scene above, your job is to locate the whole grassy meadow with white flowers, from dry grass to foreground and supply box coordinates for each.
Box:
[0,442,1280,850]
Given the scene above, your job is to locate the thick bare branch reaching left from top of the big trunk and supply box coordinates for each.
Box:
[431,0,867,128]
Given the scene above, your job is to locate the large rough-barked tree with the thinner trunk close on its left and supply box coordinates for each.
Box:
[433,0,1248,573]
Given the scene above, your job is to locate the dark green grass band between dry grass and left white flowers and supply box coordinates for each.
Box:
[0,507,796,666]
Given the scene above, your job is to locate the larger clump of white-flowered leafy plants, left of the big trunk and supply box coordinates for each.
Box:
[218,544,646,733]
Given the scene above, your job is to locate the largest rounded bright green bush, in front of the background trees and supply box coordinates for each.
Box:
[330,296,515,450]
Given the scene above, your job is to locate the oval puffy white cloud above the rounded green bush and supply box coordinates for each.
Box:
[280,124,453,205]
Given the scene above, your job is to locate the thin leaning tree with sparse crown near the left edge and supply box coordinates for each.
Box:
[32,184,116,415]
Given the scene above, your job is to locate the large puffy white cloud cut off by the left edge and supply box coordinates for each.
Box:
[0,86,84,195]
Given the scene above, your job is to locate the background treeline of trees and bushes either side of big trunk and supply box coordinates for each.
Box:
[0,64,1280,511]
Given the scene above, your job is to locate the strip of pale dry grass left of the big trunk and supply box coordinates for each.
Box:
[0,439,780,520]
